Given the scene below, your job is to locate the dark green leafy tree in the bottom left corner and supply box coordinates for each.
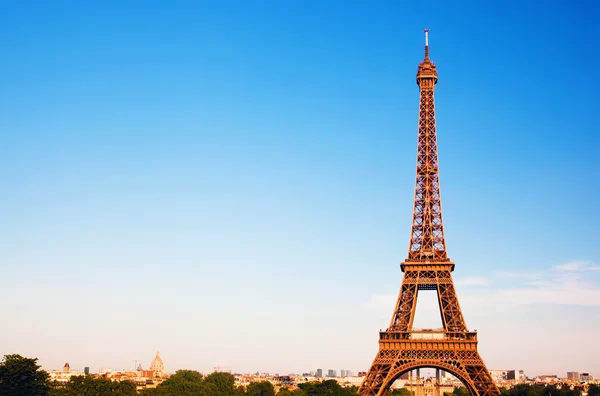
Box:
[0,355,50,396]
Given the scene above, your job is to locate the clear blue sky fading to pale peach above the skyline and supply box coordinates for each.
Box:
[0,0,600,376]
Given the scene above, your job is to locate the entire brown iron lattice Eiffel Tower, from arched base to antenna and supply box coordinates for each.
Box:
[359,30,500,396]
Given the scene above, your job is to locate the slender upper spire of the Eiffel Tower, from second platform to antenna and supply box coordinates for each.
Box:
[405,30,450,263]
